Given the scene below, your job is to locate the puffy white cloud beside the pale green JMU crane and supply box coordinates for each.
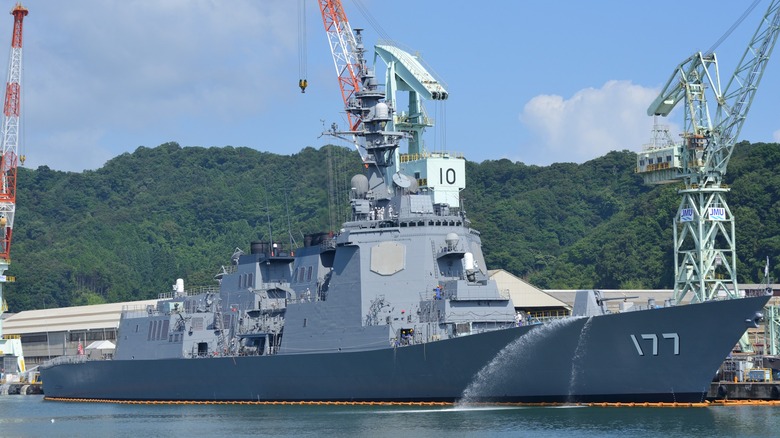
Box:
[518,80,666,165]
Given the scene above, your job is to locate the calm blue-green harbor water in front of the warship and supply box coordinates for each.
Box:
[0,395,780,438]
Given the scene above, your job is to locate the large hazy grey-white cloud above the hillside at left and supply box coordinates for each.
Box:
[22,0,297,171]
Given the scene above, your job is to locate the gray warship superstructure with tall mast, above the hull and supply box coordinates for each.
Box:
[109,34,516,359]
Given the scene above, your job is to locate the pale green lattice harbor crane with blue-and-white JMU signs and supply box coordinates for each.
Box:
[637,0,780,302]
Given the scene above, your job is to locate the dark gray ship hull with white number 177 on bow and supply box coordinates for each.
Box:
[41,297,769,403]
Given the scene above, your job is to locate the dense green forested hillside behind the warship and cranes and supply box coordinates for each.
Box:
[4,143,780,311]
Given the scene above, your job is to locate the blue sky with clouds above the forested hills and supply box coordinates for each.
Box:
[6,0,780,171]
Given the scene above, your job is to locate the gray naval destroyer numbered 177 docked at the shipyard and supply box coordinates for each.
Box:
[41,37,769,403]
